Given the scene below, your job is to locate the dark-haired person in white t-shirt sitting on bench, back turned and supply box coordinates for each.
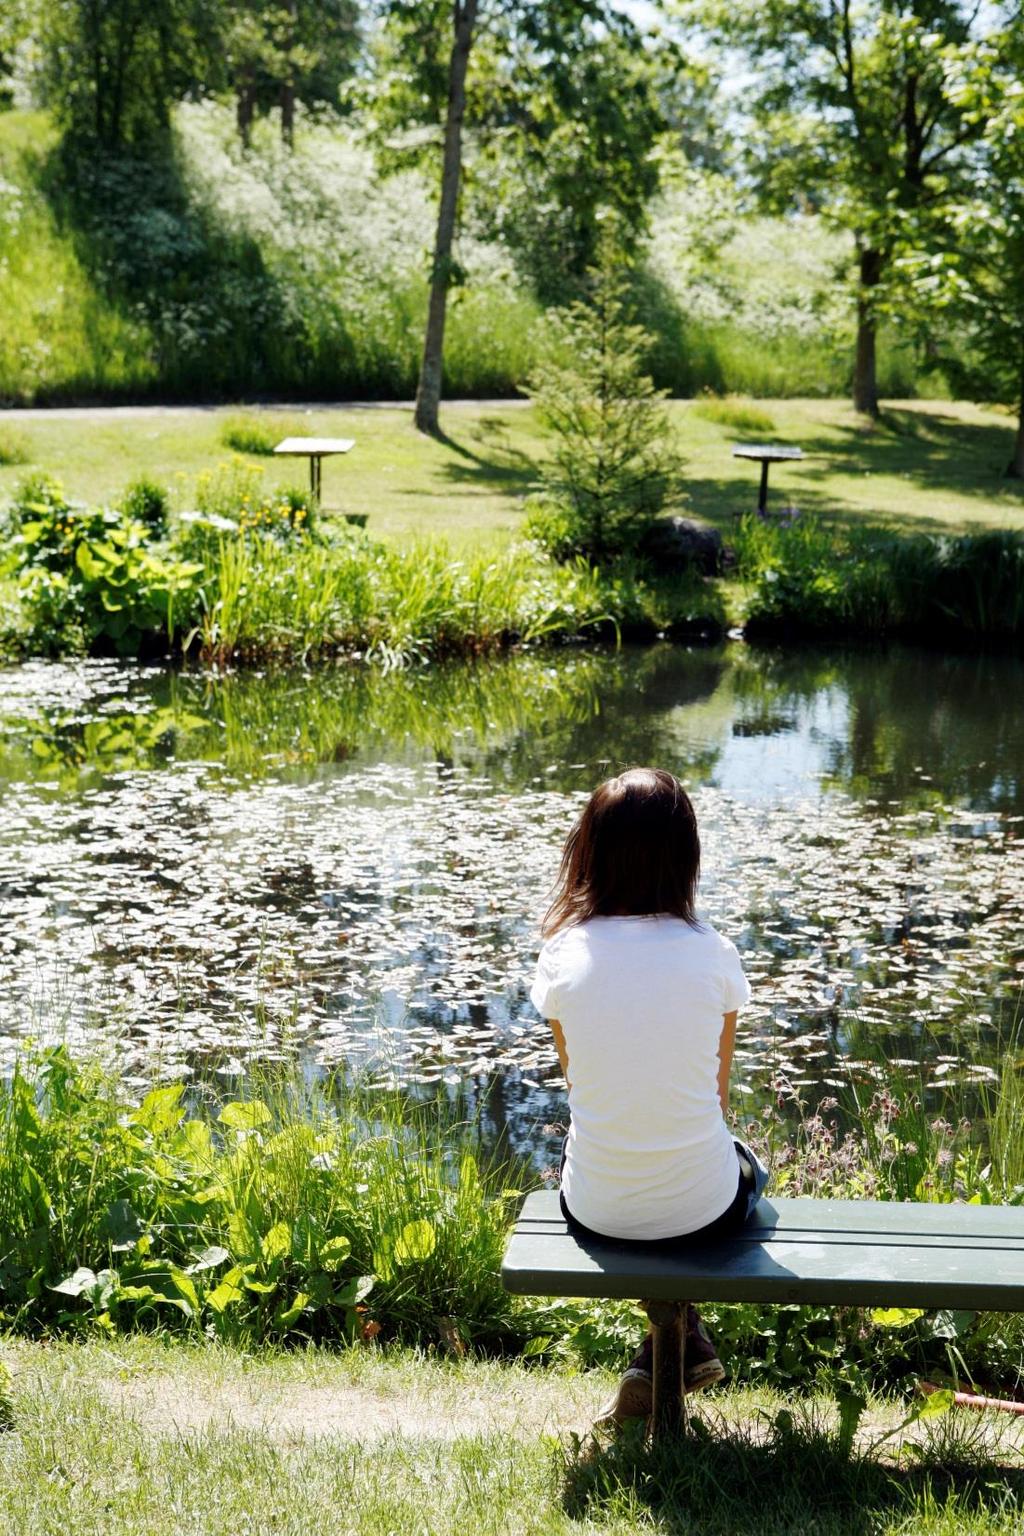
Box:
[530,768,768,1425]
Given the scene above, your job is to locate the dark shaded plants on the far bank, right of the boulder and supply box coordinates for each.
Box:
[737,518,1024,645]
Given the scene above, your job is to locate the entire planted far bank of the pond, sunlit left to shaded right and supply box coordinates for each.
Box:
[0,467,1024,664]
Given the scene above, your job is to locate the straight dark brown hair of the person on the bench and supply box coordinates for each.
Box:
[542,768,700,938]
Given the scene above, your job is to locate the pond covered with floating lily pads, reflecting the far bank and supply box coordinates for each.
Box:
[0,644,1024,1147]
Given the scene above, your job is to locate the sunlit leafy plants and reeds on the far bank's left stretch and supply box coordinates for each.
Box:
[8,459,725,664]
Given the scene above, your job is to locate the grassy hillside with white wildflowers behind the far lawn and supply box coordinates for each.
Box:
[0,101,964,402]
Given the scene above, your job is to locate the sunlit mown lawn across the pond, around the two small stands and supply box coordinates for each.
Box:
[0,401,1024,547]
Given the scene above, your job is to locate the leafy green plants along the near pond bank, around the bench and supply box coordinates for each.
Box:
[0,1048,1024,1398]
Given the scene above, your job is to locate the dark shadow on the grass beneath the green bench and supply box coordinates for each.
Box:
[562,1410,1024,1536]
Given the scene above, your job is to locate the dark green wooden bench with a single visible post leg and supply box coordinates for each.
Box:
[502,1190,1024,1438]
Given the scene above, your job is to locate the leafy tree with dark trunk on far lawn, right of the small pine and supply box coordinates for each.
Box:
[691,0,999,412]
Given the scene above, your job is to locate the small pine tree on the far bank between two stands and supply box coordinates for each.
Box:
[528,261,680,559]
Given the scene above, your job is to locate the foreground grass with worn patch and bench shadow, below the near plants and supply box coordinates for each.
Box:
[0,1338,1024,1536]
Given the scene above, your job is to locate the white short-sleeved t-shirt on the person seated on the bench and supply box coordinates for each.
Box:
[530,915,751,1240]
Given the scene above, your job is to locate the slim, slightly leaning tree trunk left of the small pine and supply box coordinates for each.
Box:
[416,0,477,436]
